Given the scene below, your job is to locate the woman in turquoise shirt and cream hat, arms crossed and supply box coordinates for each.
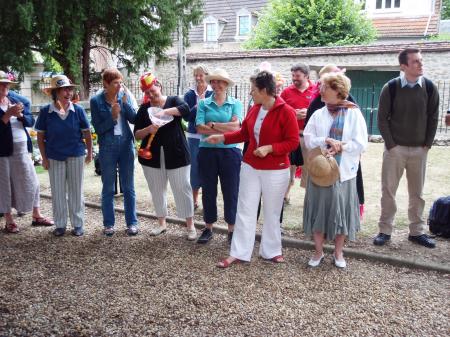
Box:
[196,69,242,243]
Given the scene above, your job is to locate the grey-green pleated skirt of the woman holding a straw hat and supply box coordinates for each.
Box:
[303,178,360,240]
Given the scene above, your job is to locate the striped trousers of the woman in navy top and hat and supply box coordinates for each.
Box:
[48,156,84,228]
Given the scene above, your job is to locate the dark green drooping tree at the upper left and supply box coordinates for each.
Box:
[0,0,201,96]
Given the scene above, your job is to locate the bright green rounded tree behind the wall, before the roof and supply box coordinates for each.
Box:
[245,0,376,49]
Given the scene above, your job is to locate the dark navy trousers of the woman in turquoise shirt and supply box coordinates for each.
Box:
[198,147,242,225]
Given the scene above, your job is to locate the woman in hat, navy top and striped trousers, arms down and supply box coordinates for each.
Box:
[35,75,92,236]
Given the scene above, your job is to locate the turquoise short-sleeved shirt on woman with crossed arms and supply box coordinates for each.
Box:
[195,94,242,148]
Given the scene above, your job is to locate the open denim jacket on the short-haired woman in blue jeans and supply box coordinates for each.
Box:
[90,92,136,146]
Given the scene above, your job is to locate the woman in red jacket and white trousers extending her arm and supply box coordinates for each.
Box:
[206,71,299,268]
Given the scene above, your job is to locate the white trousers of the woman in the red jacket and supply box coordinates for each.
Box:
[230,163,289,261]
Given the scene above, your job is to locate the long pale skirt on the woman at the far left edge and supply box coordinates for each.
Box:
[0,142,39,213]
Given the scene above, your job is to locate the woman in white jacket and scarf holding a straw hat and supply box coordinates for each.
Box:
[303,73,367,268]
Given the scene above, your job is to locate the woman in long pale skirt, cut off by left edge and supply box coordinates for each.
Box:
[0,71,53,233]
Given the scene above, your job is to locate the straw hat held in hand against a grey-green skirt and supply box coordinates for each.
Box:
[308,147,339,187]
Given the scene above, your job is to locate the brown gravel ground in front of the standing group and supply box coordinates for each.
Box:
[0,199,450,337]
